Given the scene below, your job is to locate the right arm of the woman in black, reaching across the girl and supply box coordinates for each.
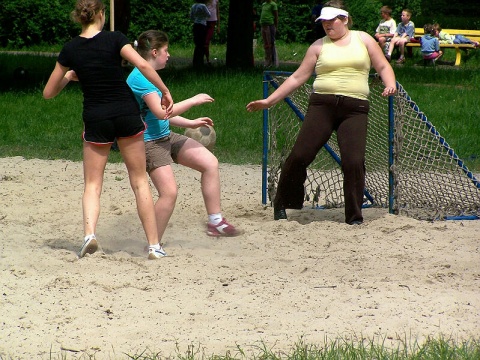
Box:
[120,44,173,117]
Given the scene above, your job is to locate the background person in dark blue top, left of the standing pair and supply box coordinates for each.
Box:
[190,0,211,69]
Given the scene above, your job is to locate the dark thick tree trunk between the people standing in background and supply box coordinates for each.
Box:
[226,0,254,68]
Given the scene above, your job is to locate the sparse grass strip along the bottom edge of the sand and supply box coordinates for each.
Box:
[23,336,480,360]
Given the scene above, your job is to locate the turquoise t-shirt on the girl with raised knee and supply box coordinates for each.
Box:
[127,68,170,141]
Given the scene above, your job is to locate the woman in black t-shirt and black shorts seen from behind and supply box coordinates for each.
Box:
[43,0,173,259]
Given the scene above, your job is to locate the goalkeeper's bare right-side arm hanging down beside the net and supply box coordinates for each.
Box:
[360,32,397,96]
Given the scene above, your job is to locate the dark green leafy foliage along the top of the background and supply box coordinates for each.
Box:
[0,0,480,49]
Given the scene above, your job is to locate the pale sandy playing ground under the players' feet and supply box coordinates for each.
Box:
[0,157,480,359]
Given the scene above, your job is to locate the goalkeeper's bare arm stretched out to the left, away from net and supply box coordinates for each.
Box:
[247,39,318,111]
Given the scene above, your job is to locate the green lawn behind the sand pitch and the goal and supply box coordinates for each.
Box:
[0,43,480,170]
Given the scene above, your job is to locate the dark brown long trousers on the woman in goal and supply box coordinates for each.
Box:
[274,93,369,223]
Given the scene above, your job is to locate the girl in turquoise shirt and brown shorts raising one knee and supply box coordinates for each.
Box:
[127,30,240,248]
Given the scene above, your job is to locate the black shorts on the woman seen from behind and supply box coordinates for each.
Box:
[83,115,147,144]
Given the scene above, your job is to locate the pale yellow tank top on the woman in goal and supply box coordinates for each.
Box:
[313,31,371,100]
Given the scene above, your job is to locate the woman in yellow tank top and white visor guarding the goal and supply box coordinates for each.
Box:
[247,0,396,225]
